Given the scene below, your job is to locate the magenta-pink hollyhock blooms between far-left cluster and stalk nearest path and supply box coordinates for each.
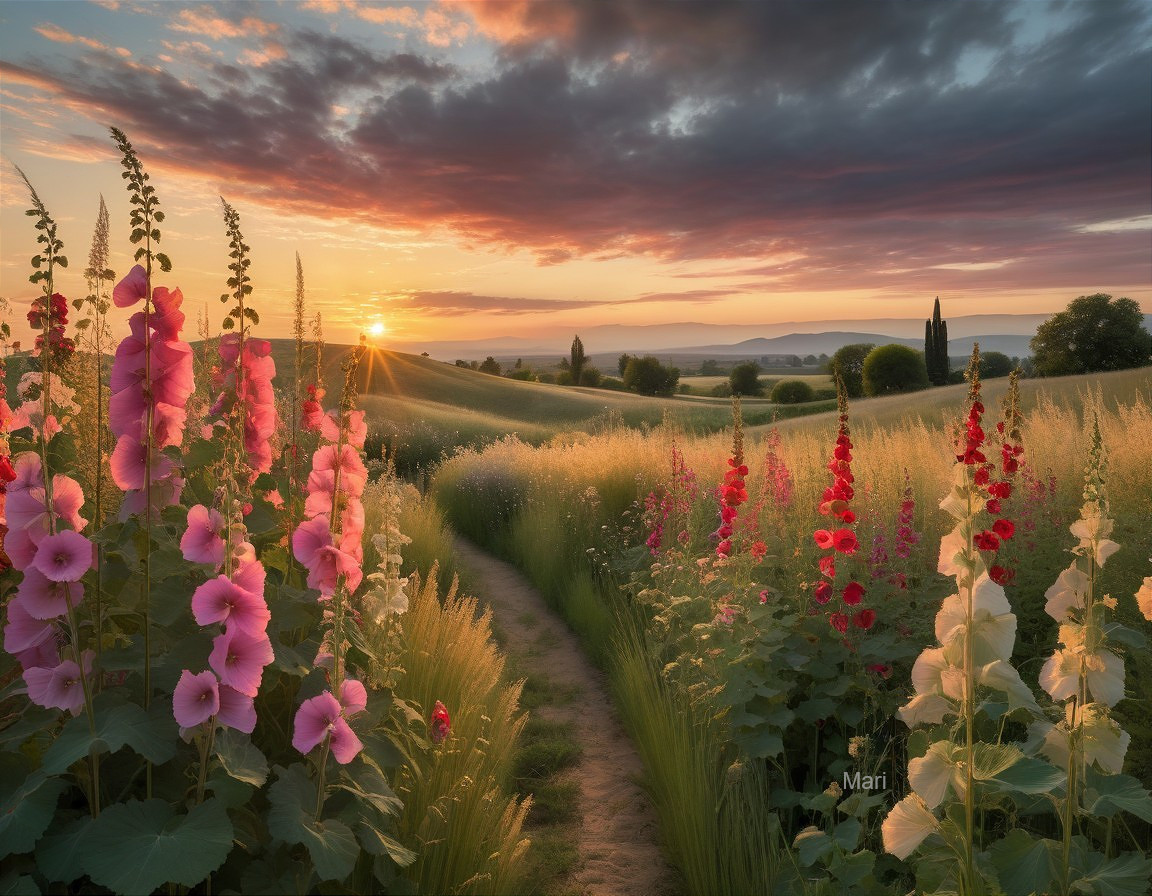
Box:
[173,501,273,734]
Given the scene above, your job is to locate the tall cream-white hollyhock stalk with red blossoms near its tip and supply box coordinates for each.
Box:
[882,347,1039,896]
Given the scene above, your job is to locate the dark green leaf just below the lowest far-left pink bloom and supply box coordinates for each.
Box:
[40,703,176,775]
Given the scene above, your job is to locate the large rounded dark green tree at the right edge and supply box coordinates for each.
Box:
[1031,293,1152,377]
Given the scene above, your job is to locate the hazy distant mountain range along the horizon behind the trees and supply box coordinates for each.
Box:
[386,314,1152,360]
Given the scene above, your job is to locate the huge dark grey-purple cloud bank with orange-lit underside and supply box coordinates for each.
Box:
[5,0,1152,288]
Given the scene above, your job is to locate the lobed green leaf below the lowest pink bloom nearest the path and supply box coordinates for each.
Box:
[268,762,359,881]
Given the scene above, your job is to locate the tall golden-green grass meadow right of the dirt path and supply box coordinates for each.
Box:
[432,369,1152,894]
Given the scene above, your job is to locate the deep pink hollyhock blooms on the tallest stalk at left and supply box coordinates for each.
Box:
[108,265,195,517]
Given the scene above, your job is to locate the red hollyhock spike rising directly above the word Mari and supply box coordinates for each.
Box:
[812,389,876,635]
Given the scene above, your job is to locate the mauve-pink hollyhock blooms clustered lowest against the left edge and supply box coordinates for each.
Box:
[3,451,93,714]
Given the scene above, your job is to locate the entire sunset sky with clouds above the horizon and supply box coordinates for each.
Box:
[0,0,1152,349]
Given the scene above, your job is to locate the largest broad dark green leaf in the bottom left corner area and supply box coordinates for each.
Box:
[84,799,233,893]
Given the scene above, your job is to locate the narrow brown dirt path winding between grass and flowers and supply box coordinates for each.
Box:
[456,537,674,896]
